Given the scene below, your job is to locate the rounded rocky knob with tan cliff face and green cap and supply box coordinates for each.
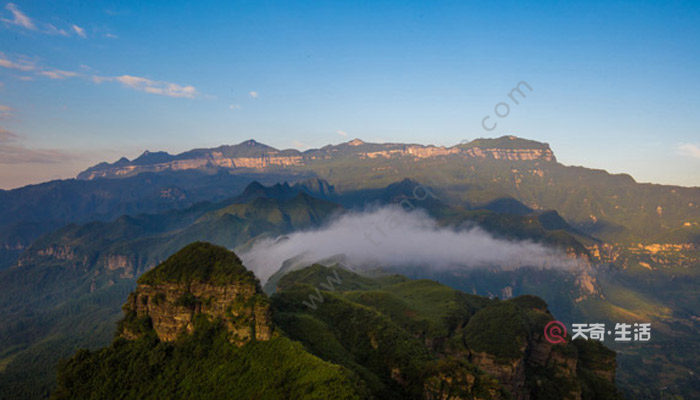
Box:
[119,243,272,345]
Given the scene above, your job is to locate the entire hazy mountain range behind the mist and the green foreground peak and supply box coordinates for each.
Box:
[0,136,700,399]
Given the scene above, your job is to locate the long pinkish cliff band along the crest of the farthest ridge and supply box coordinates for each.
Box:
[78,136,556,180]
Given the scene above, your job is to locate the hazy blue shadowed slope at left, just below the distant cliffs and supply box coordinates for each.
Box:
[0,170,308,269]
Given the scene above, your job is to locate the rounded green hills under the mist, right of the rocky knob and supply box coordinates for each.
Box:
[272,265,619,399]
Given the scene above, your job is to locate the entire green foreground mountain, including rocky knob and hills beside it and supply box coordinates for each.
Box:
[53,243,620,399]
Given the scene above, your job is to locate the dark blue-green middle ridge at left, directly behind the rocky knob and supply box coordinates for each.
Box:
[0,182,340,398]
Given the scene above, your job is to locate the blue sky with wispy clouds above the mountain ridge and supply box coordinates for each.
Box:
[0,0,700,188]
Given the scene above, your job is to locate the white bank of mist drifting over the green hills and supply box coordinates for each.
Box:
[239,206,581,283]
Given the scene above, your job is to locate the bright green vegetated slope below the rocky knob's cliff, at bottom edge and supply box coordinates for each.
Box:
[52,325,365,400]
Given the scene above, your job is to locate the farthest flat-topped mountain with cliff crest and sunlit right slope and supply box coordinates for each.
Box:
[72,136,700,245]
